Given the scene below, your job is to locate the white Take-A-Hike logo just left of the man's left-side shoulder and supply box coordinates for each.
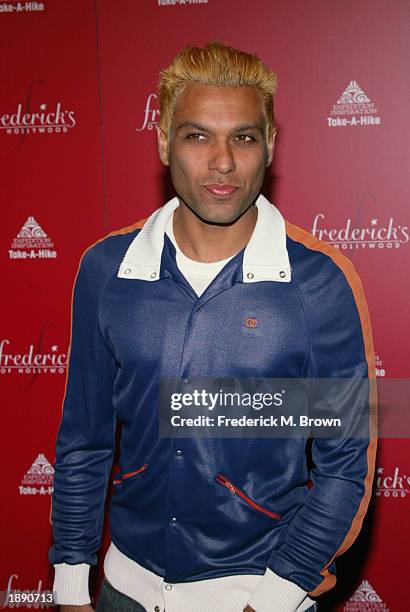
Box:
[9,217,57,259]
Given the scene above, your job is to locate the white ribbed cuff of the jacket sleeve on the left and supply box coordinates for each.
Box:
[53,563,91,606]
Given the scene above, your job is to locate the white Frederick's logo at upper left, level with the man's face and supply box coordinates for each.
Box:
[0,102,76,135]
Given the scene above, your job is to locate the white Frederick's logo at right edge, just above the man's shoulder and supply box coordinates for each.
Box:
[312,213,409,250]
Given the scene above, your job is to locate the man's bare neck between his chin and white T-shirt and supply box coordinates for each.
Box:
[173,202,258,263]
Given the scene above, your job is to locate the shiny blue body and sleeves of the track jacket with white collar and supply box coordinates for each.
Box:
[49,196,376,609]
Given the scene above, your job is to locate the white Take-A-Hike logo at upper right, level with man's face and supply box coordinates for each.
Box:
[327,81,381,127]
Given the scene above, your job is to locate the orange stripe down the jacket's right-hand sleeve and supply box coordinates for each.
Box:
[285,221,377,597]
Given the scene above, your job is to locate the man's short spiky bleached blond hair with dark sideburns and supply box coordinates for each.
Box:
[159,42,278,137]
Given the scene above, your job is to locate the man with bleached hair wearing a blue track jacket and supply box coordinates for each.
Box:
[49,43,376,612]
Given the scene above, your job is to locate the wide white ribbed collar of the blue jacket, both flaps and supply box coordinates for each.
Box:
[117,195,291,283]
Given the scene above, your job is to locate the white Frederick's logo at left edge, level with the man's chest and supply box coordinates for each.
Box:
[0,338,67,374]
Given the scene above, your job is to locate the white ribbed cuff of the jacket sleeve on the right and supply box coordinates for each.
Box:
[248,568,307,612]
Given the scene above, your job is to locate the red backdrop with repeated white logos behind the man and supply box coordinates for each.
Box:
[0,0,410,612]
